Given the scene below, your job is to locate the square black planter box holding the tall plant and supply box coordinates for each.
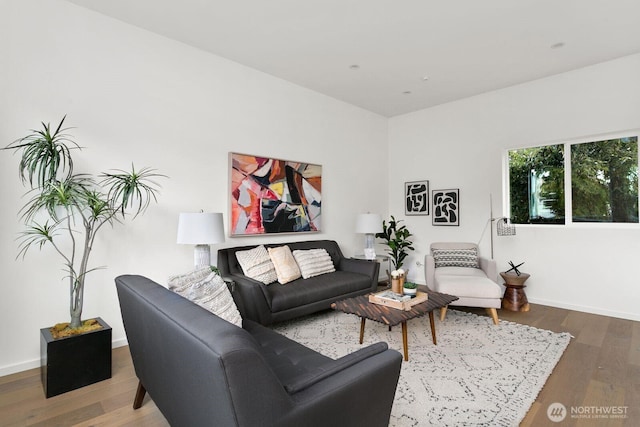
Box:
[40,317,111,398]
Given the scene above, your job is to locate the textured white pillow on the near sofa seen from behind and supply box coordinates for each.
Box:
[169,267,242,327]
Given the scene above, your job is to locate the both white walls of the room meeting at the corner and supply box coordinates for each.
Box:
[0,0,640,426]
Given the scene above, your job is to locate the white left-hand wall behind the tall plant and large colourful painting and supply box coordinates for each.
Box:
[0,0,388,375]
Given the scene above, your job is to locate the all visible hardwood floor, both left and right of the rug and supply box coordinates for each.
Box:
[0,304,640,427]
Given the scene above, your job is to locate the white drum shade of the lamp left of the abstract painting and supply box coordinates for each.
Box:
[178,212,224,245]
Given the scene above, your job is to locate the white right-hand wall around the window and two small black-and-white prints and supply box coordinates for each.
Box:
[389,55,640,320]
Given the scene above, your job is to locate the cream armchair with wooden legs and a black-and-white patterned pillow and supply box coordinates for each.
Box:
[424,242,503,325]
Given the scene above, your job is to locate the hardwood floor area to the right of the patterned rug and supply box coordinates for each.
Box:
[460,304,640,427]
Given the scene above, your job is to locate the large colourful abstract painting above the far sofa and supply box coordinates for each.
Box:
[229,153,322,236]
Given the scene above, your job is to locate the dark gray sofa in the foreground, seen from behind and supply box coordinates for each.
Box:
[115,275,402,427]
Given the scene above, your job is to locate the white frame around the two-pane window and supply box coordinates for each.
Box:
[502,128,640,229]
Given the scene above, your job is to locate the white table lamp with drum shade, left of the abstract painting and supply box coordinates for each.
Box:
[177,212,224,268]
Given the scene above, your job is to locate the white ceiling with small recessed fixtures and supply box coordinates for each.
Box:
[68,0,640,117]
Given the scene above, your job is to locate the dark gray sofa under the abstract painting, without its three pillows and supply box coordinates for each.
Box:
[217,240,380,325]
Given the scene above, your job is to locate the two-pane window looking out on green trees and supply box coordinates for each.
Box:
[508,136,638,224]
